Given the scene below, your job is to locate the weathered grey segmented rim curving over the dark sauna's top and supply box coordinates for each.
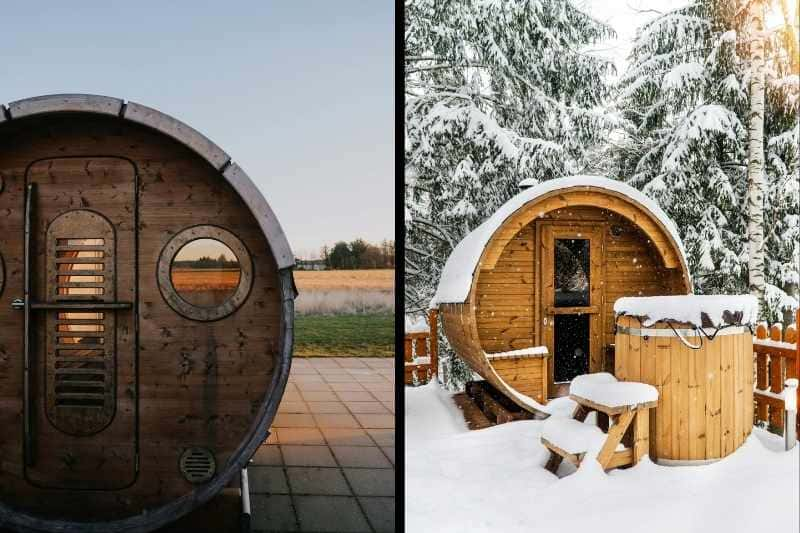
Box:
[0,94,294,270]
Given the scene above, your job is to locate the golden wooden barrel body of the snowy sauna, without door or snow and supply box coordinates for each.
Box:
[440,196,690,408]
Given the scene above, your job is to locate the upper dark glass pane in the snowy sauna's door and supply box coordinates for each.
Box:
[553,239,589,307]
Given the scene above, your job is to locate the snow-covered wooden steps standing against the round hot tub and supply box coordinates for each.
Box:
[541,372,658,473]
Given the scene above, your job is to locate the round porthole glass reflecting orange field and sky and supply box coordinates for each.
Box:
[171,239,241,307]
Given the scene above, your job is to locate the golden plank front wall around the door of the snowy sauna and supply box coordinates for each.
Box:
[475,206,688,353]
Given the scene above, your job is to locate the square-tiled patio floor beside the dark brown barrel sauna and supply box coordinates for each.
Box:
[248,357,395,532]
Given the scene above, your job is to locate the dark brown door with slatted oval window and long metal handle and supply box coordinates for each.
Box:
[16,157,138,490]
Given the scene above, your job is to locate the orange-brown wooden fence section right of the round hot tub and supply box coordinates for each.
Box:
[753,311,800,433]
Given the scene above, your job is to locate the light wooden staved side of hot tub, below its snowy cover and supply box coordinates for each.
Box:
[615,316,753,461]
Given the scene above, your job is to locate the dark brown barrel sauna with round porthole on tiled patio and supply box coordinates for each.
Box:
[0,95,295,533]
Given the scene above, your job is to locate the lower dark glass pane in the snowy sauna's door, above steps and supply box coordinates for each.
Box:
[553,315,589,383]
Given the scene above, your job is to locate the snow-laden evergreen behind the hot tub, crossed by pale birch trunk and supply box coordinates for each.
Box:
[613,0,800,321]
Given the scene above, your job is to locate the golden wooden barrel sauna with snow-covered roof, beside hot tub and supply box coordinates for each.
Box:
[431,176,692,411]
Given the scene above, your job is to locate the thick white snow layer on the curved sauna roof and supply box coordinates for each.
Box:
[431,176,686,308]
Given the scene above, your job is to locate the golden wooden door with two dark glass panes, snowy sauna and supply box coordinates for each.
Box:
[538,222,604,398]
